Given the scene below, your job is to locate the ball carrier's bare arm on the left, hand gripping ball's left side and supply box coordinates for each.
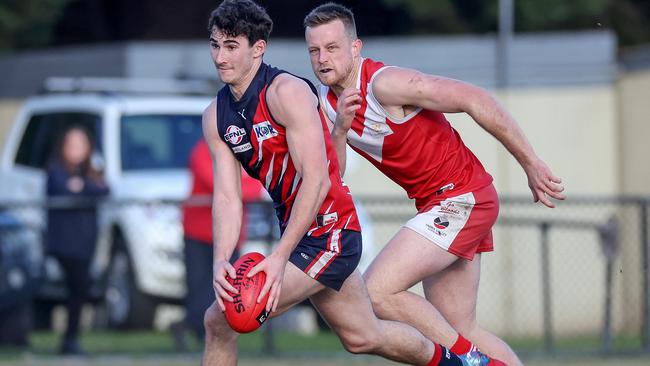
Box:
[203,101,243,311]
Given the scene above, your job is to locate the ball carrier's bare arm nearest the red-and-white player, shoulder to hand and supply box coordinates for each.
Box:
[249,74,331,311]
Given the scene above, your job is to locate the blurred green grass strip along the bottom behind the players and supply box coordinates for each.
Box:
[0,332,650,366]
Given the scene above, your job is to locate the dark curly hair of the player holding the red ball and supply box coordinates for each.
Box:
[208,0,273,45]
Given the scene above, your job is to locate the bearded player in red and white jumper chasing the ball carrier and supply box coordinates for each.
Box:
[304,3,565,365]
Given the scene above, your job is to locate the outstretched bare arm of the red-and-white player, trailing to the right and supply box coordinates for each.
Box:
[373,67,566,208]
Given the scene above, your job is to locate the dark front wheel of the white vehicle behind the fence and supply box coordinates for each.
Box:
[105,236,157,329]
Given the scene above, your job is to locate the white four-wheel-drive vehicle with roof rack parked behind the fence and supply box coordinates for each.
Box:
[0,78,217,328]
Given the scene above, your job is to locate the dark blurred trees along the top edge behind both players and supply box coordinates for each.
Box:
[0,0,650,51]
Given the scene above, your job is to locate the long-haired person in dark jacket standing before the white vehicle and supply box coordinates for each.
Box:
[45,126,108,354]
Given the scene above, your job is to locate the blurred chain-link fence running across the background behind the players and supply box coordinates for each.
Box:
[0,196,650,353]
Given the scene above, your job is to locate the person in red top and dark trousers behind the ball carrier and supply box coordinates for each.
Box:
[178,139,262,349]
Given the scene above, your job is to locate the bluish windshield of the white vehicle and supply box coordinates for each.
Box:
[120,114,202,170]
